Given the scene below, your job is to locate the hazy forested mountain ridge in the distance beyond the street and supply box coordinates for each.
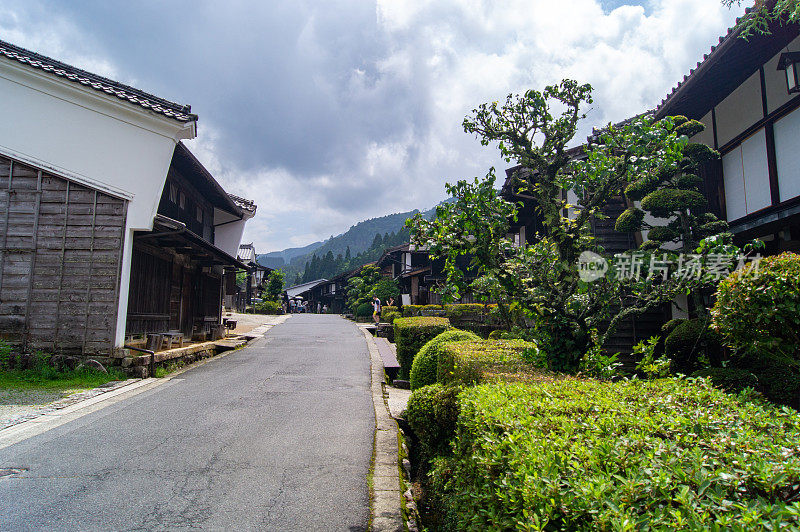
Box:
[257,208,436,284]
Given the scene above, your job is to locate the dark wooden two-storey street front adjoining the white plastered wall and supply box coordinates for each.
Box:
[125,144,246,338]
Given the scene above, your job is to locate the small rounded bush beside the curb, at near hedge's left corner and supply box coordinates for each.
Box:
[405,384,461,459]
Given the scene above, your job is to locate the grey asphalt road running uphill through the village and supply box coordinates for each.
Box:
[0,314,375,531]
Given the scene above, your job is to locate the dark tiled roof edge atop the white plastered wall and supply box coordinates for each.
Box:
[0,41,197,122]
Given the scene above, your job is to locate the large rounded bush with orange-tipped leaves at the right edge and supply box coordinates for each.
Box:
[711,253,800,359]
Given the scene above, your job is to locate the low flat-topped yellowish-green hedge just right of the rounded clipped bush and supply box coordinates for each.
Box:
[436,340,548,385]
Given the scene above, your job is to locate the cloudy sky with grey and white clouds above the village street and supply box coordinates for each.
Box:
[0,0,743,252]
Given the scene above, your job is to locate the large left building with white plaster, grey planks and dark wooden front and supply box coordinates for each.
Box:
[0,41,255,356]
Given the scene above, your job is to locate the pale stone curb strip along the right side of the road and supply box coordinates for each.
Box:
[361,328,406,532]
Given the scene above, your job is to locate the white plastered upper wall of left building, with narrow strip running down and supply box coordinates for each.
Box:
[0,59,196,347]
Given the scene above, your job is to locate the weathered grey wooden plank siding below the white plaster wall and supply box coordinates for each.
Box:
[0,157,127,355]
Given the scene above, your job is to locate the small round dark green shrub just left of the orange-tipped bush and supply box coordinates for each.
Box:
[664,318,720,375]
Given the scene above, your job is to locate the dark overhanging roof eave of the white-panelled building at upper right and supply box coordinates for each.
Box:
[655,9,800,119]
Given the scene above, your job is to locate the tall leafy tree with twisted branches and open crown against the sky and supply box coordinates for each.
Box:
[414,80,712,370]
